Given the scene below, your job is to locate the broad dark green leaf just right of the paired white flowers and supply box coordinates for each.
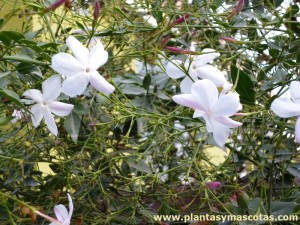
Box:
[231,65,255,104]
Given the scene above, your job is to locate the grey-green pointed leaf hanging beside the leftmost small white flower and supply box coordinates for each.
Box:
[64,112,81,144]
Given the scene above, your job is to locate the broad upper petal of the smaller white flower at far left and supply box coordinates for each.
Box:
[42,75,61,102]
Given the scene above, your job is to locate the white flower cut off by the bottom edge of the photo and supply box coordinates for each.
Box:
[49,194,73,225]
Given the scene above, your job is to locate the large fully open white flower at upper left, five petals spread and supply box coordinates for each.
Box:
[52,36,115,97]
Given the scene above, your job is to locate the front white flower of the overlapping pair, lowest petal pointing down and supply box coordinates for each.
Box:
[173,79,242,146]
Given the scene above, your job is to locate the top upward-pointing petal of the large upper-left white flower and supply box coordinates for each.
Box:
[66,36,90,67]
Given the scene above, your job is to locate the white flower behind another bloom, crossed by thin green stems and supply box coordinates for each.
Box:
[165,48,228,94]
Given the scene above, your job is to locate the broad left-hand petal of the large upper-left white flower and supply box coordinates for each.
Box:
[51,52,86,77]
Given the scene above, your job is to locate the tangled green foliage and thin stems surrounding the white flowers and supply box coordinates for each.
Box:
[0,0,300,225]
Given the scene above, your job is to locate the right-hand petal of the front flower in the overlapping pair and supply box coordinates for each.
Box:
[212,93,240,116]
